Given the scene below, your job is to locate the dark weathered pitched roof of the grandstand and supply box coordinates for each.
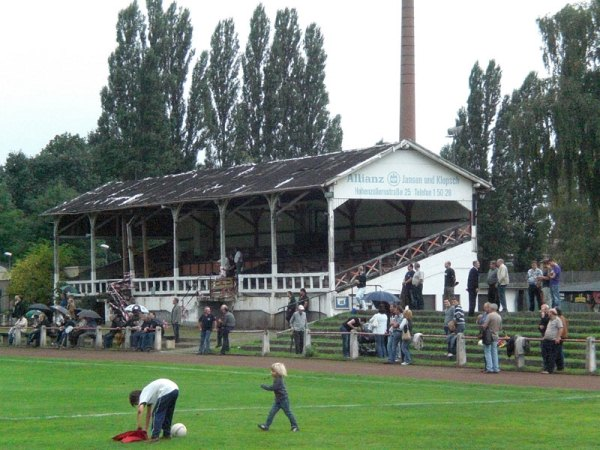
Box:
[44,141,489,215]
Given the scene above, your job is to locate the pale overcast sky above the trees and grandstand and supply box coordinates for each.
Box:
[0,0,572,165]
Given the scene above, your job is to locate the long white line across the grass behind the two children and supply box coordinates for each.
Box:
[0,395,600,422]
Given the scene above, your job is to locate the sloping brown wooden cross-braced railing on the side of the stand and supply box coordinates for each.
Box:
[335,222,471,292]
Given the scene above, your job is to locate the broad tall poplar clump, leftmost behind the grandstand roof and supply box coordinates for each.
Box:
[90,0,196,180]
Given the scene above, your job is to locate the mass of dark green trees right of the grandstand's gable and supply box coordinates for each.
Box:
[442,0,600,270]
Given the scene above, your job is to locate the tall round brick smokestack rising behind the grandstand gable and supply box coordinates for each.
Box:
[400,0,417,141]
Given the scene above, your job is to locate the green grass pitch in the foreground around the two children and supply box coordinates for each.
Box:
[0,357,600,450]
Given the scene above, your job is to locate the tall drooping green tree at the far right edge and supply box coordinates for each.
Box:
[538,1,600,268]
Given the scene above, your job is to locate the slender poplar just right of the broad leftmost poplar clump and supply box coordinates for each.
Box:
[205,19,241,167]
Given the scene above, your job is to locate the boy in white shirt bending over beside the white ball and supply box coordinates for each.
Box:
[129,378,179,442]
